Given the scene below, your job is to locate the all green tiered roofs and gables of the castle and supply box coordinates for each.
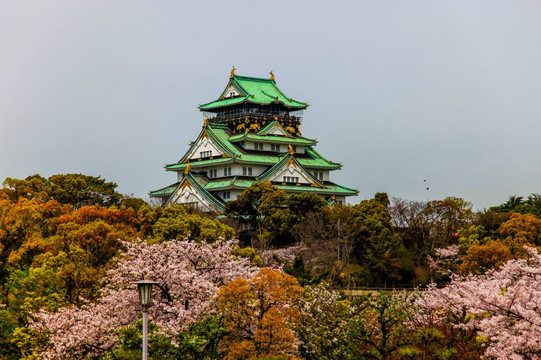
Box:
[150,69,358,211]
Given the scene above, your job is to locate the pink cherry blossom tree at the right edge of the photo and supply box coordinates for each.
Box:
[421,248,541,360]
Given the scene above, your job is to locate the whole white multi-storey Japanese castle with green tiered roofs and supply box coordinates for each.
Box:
[150,67,358,212]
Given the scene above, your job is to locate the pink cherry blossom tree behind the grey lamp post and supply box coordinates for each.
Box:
[30,240,256,359]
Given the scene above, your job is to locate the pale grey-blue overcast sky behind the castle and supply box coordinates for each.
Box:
[0,0,541,210]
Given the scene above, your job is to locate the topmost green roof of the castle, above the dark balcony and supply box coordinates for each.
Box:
[199,75,308,111]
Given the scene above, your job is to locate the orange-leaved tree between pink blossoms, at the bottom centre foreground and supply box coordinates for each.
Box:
[217,268,302,359]
